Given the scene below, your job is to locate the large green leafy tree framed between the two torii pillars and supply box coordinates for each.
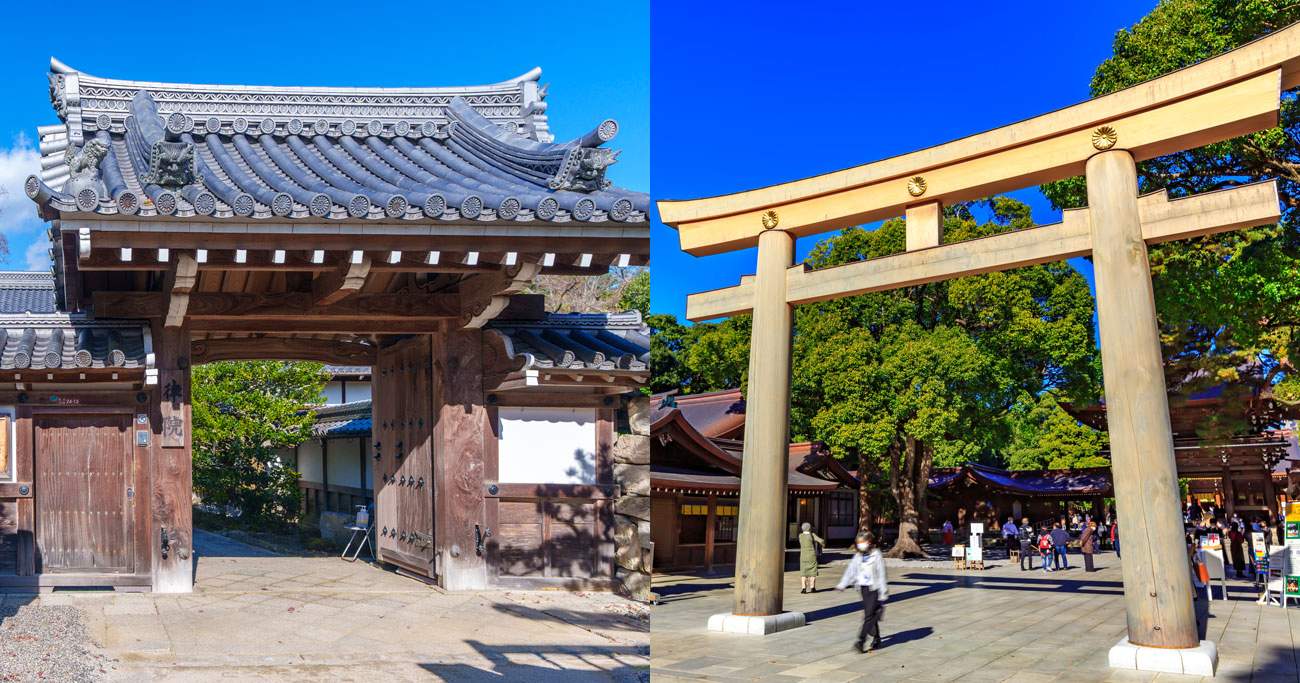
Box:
[785,198,1099,556]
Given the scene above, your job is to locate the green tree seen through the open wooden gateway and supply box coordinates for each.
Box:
[192,360,329,520]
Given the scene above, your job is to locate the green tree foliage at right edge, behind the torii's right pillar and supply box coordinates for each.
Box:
[1043,0,1300,402]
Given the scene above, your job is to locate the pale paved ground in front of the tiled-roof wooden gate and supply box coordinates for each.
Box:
[22,531,649,683]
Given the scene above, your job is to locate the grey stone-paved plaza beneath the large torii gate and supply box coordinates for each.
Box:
[650,553,1300,683]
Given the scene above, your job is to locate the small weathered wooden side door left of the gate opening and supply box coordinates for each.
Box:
[33,414,135,572]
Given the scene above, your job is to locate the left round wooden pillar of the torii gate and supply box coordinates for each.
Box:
[733,230,794,615]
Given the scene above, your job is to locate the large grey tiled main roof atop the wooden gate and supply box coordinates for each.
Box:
[25,60,649,222]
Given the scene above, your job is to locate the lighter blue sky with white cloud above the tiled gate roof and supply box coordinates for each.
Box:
[0,0,650,269]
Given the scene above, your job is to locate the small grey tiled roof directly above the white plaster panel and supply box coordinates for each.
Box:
[488,311,650,371]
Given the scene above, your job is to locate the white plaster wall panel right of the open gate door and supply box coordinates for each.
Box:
[497,407,595,484]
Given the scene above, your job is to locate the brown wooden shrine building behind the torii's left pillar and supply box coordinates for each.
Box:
[650,389,858,571]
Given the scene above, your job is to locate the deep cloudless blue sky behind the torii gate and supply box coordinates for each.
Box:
[650,0,1156,319]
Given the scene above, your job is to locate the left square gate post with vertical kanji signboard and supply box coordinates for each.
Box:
[146,324,194,593]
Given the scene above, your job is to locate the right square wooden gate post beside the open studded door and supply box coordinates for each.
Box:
[433,329,493,591]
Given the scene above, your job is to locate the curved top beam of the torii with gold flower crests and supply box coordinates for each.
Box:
[658,33,1300,255]
